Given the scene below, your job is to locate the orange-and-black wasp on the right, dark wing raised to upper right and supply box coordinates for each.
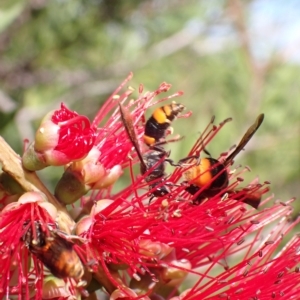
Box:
[185,114,264,208]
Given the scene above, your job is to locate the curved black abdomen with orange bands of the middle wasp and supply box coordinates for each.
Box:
[144,102,185,146]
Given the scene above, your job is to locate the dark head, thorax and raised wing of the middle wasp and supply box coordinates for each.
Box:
[119,104,181,197]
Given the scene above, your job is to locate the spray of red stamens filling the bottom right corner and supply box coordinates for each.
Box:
[180,200,300,299]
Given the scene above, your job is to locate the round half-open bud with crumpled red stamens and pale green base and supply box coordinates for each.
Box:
[22,103,95,171]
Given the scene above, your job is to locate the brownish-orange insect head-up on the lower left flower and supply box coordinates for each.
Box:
[22,221,84,280]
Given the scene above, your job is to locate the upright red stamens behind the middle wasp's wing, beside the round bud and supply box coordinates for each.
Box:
[93,75,186,169]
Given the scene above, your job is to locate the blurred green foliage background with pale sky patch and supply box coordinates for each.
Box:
[0,0,300,213]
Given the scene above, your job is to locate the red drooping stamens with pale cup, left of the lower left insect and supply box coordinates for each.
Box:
[0,192,57,299]
